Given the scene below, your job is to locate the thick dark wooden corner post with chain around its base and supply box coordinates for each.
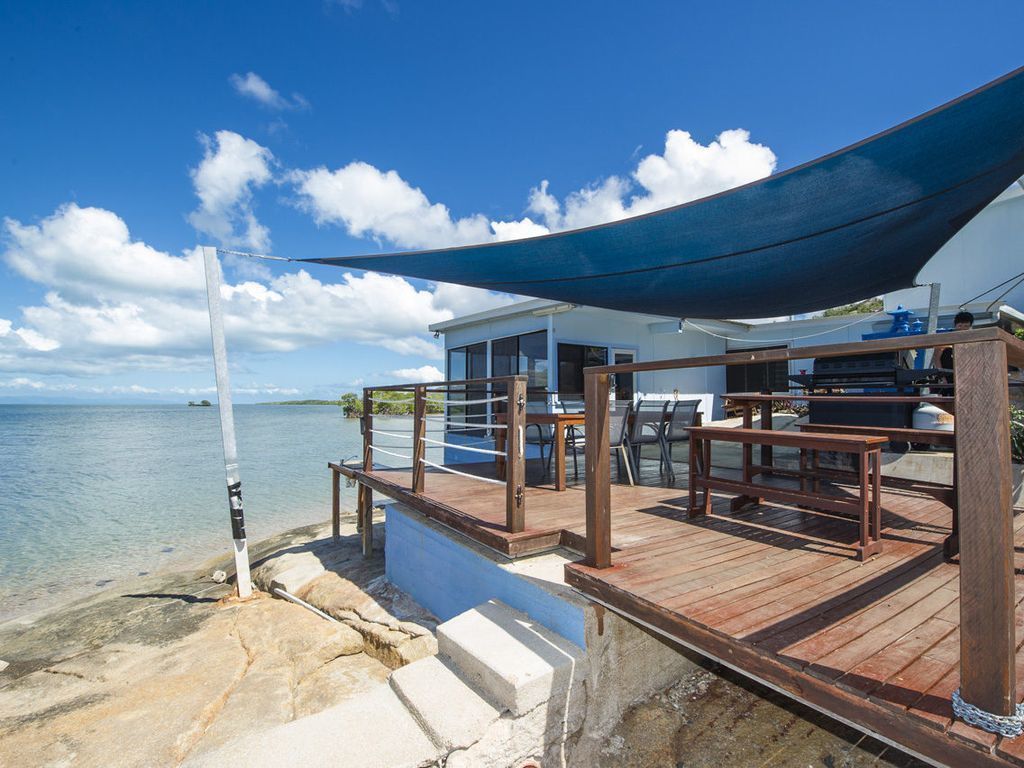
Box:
[953,341,1017,715]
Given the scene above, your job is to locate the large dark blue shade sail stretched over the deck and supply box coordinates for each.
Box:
[307,68,1024,318]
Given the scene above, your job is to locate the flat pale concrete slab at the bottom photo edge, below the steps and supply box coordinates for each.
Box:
[182,685,441,768]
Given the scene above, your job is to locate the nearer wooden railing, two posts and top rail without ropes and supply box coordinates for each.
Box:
[584,328,1024,715]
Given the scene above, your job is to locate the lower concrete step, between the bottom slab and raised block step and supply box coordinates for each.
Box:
[389,656,501,752]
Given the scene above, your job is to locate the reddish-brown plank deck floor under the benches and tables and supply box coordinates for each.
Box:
[342,464,1024,765]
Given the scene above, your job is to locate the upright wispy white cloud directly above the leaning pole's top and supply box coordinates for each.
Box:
[188,131,273,252]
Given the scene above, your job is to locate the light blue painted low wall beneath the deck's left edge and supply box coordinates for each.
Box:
[384,505,586,648]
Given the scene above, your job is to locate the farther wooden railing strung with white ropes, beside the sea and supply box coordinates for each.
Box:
[358,376,526,532]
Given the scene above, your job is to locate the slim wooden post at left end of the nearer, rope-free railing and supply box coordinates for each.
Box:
[583,374,611,568]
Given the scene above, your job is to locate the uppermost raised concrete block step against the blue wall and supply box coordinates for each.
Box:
[437,600,585,717]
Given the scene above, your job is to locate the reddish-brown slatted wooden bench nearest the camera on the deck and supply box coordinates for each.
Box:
[689,427,887,560]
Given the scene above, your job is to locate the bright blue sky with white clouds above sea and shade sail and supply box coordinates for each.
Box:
[0,0,1024,401]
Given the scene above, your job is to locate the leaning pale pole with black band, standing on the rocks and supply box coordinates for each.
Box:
[203,246,253,597]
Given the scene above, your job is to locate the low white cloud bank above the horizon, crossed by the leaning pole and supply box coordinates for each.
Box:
[0,204,511,376]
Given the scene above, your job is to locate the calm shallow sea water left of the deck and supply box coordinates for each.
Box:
[0,404,372,621]
